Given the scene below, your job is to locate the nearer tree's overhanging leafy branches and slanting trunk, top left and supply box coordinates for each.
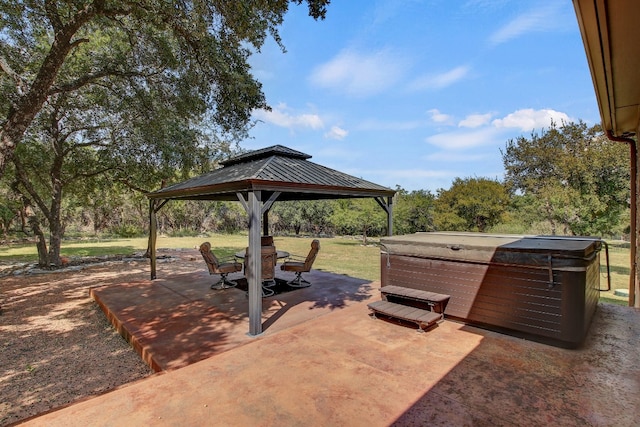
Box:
[0,0,329,176]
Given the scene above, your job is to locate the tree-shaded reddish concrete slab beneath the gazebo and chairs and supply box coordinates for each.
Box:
[91,270,370,371]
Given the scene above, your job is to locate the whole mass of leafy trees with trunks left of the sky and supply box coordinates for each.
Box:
[0,0,328,265]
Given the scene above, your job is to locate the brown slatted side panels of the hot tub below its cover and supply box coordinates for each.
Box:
[381,253,599,347]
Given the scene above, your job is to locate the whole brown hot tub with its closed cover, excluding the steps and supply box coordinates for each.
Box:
[381,233,602,348]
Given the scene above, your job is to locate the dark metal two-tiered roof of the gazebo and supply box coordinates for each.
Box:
[147,145,396,200]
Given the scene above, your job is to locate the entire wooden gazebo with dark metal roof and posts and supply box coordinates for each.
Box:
[147,145,395,336]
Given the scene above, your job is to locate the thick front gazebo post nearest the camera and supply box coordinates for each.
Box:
[245,191,262,336]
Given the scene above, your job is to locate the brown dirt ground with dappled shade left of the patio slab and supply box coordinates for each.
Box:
[0,255,194,426]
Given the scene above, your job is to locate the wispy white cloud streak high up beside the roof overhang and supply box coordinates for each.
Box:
[489,2,565,46]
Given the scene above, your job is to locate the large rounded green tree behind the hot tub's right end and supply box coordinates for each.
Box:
[502,122,630,235]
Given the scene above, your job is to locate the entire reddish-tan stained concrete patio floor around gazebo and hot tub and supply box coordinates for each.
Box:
[20,256,640,427]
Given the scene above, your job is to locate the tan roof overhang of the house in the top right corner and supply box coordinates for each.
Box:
[573,0,640,137]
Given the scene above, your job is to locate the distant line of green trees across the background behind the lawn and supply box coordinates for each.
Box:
[0,122,629,247]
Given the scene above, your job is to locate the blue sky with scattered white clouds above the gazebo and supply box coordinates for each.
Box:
[241,0,600,193]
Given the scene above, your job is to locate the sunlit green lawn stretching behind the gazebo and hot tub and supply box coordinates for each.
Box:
[0,234,630,305]
